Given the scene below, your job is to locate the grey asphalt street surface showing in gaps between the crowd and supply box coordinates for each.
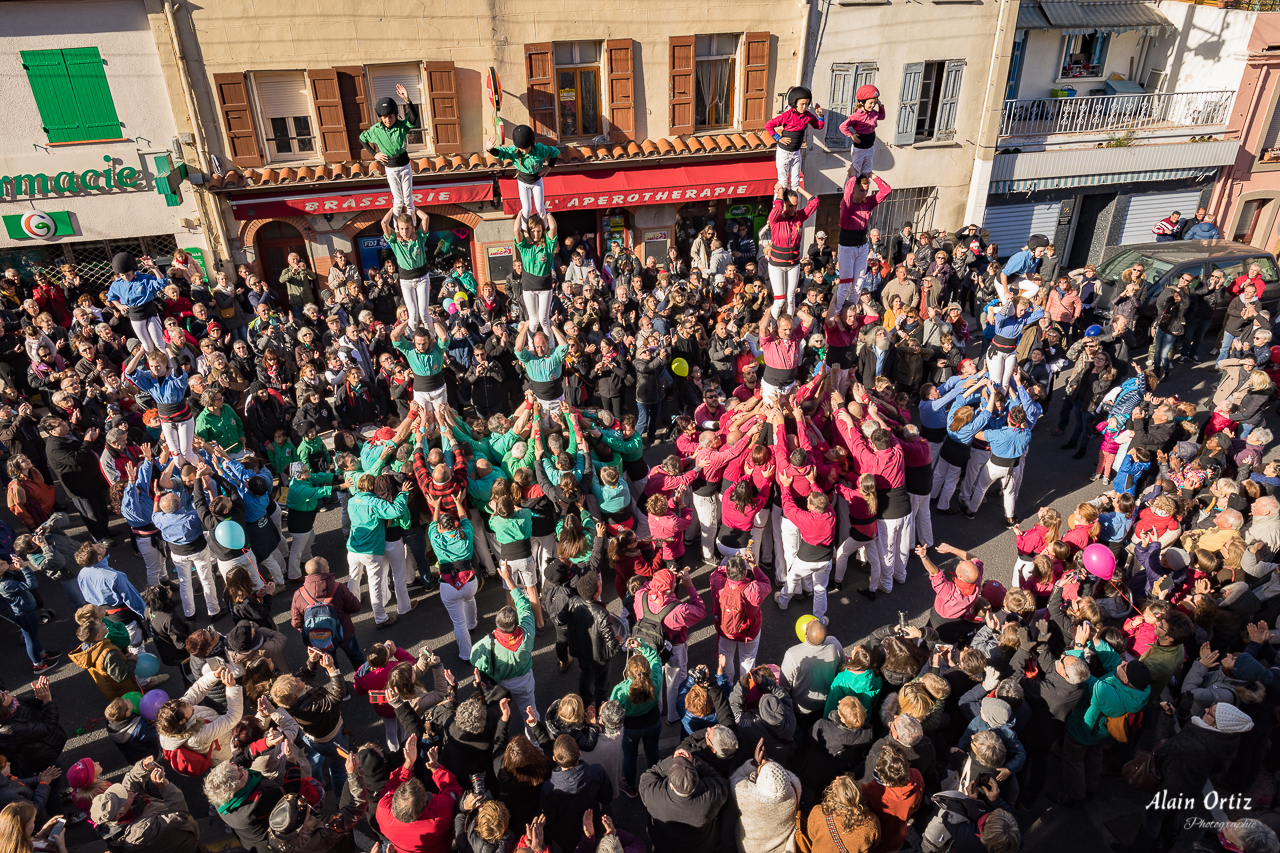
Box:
[10,350,1275,850]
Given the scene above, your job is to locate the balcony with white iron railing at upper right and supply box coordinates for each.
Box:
[1000,91,1235,142]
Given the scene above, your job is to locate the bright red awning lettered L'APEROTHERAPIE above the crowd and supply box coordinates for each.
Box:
[498,160,778,214]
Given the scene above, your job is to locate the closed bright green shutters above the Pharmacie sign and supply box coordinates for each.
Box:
[22,47,122,145]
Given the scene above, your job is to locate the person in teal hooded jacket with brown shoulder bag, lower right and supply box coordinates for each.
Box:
[1051,650,1151,807]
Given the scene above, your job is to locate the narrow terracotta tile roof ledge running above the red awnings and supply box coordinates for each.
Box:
[209,133,774,190]
